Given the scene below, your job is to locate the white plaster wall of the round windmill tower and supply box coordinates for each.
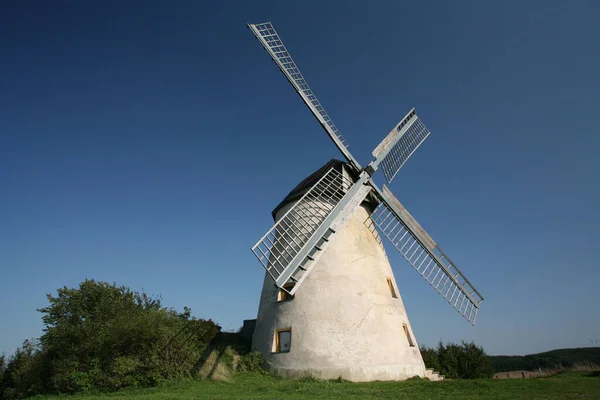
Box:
[252,200,425,381]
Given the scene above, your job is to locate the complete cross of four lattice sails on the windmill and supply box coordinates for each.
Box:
[248,22,483,325]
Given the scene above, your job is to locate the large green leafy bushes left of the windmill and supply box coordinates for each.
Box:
[0,280,221,399]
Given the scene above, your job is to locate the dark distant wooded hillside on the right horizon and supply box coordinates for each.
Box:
[489,347,600,372]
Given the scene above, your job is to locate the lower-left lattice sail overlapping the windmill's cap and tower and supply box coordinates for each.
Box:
[252,168,353,294]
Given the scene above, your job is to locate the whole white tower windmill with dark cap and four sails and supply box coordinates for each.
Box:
[248,23,483,381]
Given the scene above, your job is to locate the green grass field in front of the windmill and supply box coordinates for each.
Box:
[38,372,600,400]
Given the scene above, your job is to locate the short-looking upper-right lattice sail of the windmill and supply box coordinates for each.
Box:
[372,108,430,183]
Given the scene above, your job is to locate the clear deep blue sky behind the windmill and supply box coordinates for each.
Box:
[0,0,600,354]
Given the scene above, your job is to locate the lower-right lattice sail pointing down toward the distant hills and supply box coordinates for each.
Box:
[371,186,483,325]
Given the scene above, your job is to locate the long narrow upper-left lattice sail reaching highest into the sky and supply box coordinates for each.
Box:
[248,22,361,171]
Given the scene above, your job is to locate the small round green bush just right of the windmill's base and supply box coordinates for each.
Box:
[421,341,494,379]
